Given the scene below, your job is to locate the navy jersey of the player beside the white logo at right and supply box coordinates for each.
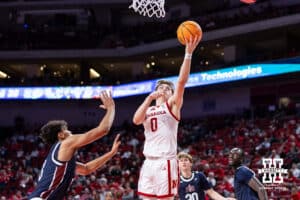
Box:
[234,166,258,200]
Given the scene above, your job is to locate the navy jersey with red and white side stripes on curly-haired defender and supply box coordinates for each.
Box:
[29,142,76,200]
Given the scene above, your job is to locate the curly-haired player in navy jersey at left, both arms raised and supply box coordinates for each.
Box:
[29,91,120,200]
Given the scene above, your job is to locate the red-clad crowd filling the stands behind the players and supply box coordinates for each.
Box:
[0,112,300,200]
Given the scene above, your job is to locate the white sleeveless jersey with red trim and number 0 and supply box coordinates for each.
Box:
[143,102,179,159]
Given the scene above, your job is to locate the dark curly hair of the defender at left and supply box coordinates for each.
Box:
[40,120,68,144]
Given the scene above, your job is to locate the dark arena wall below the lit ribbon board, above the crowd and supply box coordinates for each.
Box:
[0,88,250,126]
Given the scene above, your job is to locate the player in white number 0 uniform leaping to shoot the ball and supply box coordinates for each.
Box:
[133,37,200,200]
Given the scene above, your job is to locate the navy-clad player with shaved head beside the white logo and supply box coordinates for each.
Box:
[228,148,268,200]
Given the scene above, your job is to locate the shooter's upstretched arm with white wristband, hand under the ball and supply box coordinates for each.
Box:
[169,37,201,109]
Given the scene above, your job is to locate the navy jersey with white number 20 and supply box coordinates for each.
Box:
[179,172,212,200]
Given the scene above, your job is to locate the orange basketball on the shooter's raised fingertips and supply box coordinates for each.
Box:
[177,21,202,45]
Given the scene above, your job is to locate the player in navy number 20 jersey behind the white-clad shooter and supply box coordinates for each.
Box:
[177,152,235,200]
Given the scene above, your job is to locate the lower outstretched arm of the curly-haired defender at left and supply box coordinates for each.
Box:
[76,134,121,175]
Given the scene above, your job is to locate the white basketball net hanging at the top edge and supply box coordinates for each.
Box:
[129,0,166,18]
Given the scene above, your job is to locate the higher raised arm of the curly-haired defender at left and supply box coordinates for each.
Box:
[62,91,115,149]
